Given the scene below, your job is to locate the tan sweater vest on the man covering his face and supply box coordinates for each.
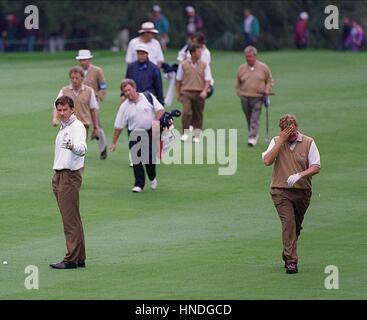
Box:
[271,135,313,189]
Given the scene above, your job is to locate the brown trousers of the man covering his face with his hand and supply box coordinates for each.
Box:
[270,188,312,263]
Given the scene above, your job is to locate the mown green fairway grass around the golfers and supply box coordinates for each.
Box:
[0,51,367,299]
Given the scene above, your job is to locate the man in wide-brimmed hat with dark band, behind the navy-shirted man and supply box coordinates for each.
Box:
[125,22,164,68]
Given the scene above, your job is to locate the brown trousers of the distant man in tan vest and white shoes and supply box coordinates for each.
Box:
[180,91,205,130]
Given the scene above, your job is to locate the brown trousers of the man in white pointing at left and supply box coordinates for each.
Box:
[52,170,86,263]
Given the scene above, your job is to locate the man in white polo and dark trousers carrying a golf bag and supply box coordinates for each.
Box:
[111,79,164,193]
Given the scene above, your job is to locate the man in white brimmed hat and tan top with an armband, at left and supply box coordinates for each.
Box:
[75,50,107,160]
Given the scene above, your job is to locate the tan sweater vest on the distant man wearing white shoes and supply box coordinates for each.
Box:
[181,60,206,91]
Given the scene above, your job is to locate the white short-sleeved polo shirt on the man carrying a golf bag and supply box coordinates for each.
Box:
[115,93,164,131]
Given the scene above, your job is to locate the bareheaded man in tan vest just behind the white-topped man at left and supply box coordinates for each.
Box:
[52,67,99,158]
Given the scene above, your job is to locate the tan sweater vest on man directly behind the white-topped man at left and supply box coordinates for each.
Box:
[62,85,93,126]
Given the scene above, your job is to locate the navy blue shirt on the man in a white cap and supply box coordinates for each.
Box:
[125,60,164,104]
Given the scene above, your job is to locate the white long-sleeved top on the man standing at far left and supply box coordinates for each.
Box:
[53,115,87,171]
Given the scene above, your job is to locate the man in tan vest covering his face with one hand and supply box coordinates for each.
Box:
[262,114,320,273]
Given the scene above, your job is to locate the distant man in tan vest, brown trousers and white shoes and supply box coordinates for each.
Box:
[176,44,212,143]
